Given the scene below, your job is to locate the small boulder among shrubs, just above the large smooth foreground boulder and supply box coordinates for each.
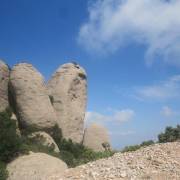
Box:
[28,131,60,153]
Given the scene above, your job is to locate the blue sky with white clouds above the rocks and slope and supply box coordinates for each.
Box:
[0,0,180,148]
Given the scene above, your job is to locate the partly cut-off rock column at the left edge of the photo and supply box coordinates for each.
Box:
[0,60,9,112]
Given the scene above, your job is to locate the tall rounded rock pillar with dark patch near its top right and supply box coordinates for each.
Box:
[47,63,87,142]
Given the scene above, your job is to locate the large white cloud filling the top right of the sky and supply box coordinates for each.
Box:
[78,0,180,65]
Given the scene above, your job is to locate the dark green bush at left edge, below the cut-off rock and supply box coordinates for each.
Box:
[0,109,22,162]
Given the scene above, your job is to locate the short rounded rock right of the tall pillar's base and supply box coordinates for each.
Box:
[83,123,110,151]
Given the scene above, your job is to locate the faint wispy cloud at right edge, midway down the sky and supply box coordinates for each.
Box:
[135,75,180,100]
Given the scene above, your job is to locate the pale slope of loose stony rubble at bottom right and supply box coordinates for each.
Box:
[58,142,180,180]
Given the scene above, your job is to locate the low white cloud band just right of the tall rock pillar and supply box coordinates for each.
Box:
[85,109,135,123]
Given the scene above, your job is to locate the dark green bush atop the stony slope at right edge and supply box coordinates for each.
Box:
[158,125,180,143]
